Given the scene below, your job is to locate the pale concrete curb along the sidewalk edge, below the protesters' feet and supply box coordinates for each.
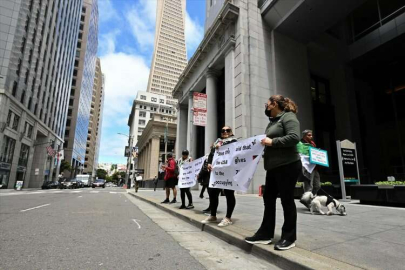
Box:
[128,192,364,270]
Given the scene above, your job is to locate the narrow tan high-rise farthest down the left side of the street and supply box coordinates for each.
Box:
[83,58,104,179]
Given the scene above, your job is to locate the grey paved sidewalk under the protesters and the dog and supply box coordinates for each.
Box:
[129,189,405,269]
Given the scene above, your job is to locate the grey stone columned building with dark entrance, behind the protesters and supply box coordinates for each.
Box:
[173,0,405,193]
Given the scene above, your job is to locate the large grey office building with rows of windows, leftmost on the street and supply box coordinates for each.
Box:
[0,0,82,188]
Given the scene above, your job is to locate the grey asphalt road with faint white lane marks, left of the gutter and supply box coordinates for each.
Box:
[0,188,204,270]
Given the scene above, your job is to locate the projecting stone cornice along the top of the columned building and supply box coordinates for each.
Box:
[173,0,239,99]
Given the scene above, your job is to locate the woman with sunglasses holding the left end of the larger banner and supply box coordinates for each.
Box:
[202,126,237,227]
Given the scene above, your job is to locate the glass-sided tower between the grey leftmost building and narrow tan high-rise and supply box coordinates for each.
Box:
[63,0,98,177]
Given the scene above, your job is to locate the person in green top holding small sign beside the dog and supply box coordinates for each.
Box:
[297,129,321,208]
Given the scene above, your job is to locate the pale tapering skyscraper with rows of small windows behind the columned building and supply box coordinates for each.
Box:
[147,0,187,104]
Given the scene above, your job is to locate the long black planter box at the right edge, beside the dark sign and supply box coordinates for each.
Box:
[351,185,405,206]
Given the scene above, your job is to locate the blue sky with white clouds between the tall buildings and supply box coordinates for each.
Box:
[98,0,205,164]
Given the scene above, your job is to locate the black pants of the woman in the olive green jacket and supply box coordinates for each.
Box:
[257,160,302,242]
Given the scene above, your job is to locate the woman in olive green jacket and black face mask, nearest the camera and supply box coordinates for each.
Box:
[245,95,301,250]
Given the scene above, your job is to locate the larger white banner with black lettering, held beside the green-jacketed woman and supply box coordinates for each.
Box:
[209,135,266,192]
